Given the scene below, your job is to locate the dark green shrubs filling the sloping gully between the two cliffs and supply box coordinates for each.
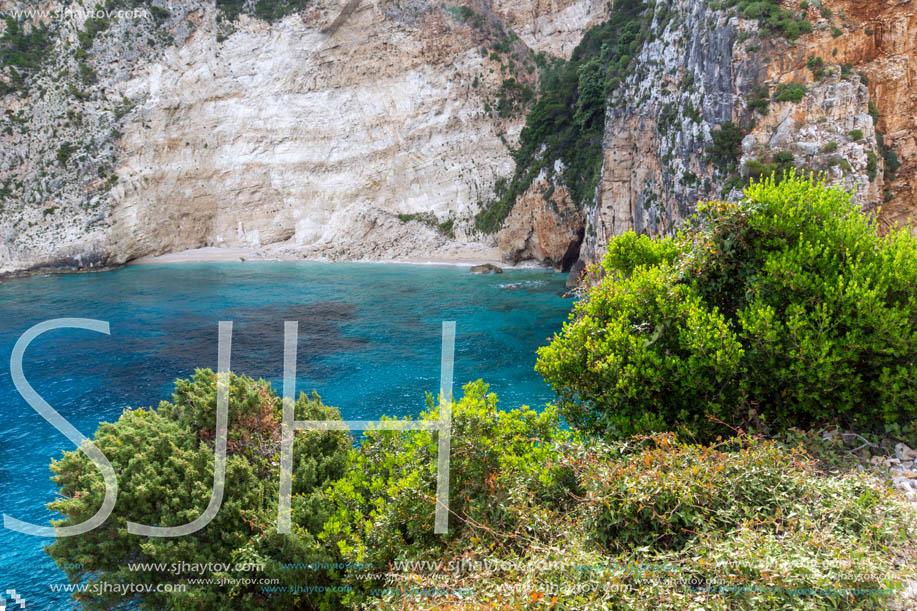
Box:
[475,0,652,233]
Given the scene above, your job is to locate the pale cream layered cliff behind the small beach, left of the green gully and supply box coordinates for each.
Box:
[0,0,592,272]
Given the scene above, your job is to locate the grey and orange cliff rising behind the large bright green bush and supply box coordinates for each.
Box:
[582,0,904,262]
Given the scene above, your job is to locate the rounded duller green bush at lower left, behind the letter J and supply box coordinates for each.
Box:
[47,369,350,609]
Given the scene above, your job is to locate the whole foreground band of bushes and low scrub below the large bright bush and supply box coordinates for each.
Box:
[50,371,917,610]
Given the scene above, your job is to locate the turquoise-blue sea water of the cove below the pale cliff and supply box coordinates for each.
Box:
[0,262,571,609]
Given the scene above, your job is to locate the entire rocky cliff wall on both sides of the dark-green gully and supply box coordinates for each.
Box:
[0,0,917,273]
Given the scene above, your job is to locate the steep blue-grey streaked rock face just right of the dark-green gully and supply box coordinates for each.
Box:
[582,0,763,262]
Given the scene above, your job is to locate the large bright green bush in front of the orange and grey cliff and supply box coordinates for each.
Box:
[536,174,917,443]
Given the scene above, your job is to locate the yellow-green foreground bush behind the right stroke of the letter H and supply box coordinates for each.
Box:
[321,380,575,606]
